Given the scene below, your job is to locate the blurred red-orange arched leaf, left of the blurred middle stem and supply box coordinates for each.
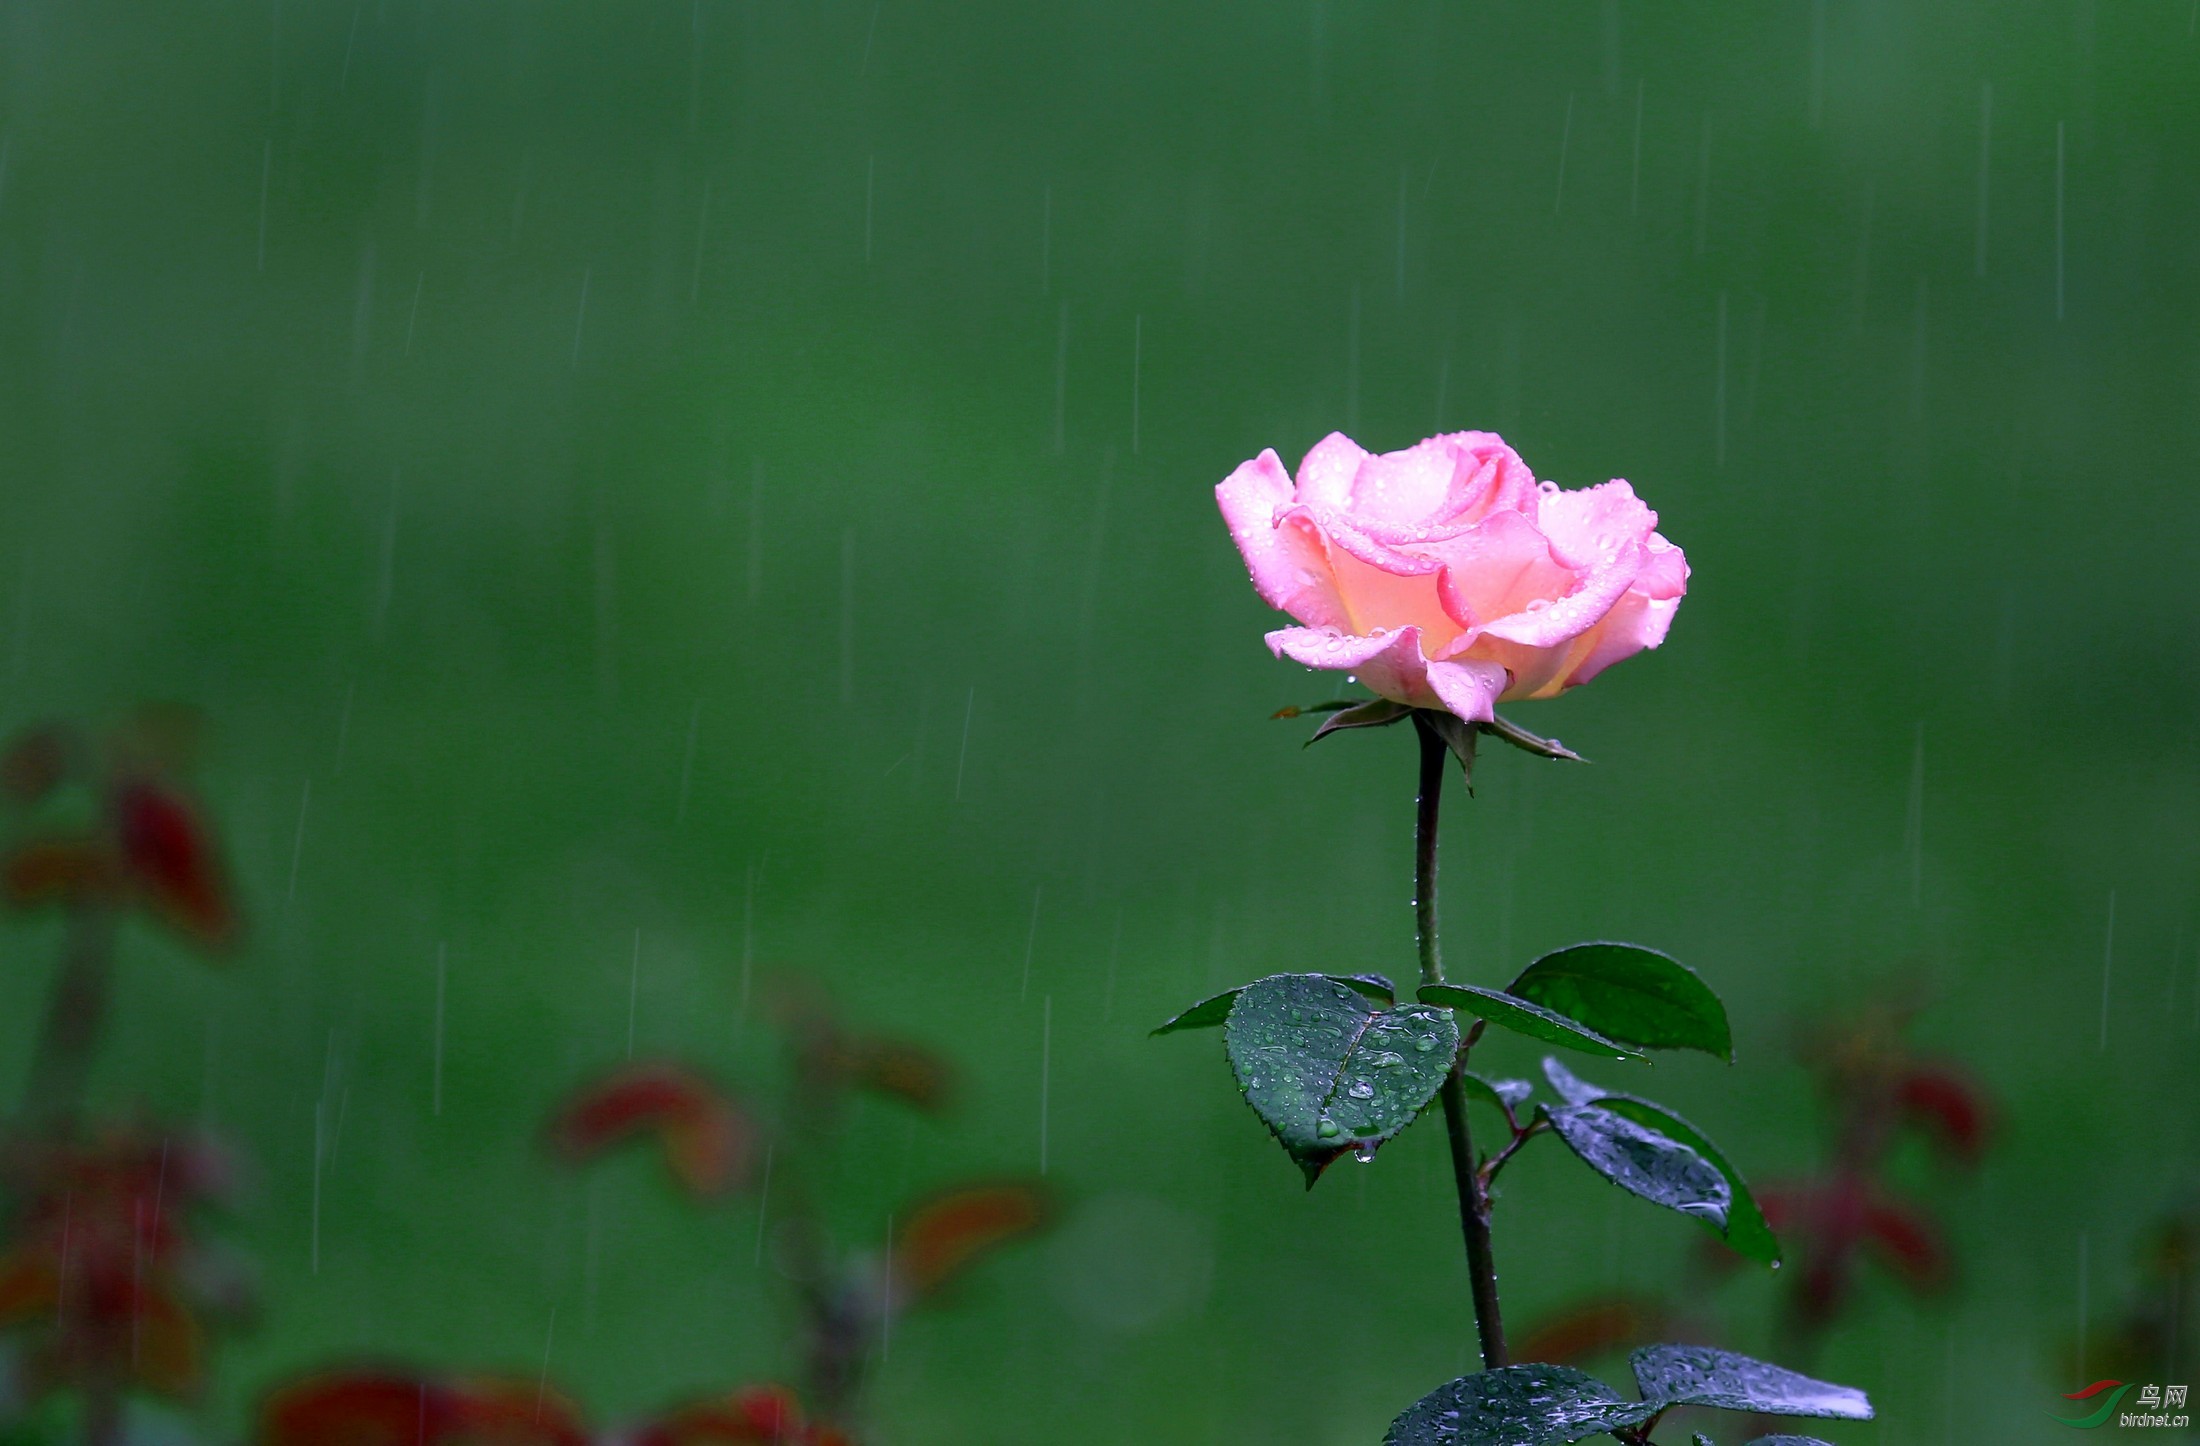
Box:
[550,1063,755,1195]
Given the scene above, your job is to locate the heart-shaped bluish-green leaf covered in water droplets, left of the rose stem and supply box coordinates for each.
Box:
[1223,975,1459,1191]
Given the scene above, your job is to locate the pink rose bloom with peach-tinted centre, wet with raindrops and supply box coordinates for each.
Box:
[1214,431,1687,722]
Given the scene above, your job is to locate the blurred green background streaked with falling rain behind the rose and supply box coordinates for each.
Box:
[0,0,2200,1446]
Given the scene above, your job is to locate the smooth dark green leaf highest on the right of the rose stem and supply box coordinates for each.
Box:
[1505,944,1734,1063]
